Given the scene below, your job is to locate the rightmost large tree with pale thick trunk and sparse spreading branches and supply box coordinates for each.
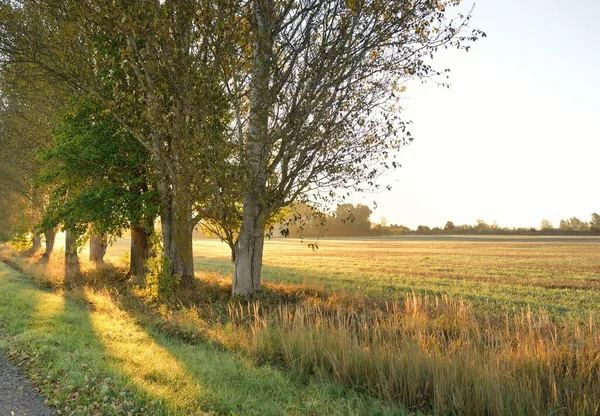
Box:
[209,0,481,296]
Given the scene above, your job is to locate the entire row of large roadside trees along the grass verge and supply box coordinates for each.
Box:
[0,0,484,296]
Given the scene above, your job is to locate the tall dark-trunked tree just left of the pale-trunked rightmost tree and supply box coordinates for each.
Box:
[0,0,237,284]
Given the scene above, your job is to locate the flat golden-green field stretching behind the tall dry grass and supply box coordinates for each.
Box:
[190,239,600,321]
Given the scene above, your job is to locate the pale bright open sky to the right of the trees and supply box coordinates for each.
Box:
[351,0,600,228]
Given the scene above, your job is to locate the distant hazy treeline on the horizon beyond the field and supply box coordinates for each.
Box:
[279,204,600,237]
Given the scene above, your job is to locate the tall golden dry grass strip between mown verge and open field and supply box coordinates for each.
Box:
[0,245,600,415]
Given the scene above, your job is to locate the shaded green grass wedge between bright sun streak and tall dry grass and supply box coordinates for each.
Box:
[119,306,406,415]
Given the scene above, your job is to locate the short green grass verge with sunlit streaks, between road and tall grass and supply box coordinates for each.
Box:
[0,263,405,415]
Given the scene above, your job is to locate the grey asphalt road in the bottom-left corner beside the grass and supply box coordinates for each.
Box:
[0,354,56,416]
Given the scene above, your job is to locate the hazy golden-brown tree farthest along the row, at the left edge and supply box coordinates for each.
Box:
[0,56,66,250]
